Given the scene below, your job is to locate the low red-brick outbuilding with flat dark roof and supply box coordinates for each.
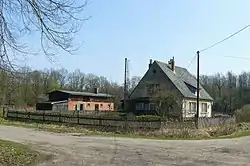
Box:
[36,88,114,111]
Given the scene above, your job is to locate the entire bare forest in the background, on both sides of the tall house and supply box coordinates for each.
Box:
[0,67,250,113]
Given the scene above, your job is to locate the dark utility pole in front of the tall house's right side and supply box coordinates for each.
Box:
[196,51,200,129]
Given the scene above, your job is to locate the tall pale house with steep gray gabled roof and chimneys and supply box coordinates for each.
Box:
[126,58,213,118]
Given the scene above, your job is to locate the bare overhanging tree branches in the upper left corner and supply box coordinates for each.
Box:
[0,0,88,70]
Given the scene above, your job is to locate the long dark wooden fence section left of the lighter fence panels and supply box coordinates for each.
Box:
[6,111,161,129]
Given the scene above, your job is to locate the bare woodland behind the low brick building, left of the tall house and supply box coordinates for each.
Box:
[0,67,140,108]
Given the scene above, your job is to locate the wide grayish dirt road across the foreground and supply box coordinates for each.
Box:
[0,126,250,166]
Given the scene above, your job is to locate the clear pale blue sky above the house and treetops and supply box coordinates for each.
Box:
[22,0,250,83]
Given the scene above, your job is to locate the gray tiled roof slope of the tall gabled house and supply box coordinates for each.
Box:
[155,61,213,100]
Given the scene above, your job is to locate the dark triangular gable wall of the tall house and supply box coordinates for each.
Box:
[129,62,181,99]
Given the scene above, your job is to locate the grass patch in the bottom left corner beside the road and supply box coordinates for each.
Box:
[0,140,39,166]
